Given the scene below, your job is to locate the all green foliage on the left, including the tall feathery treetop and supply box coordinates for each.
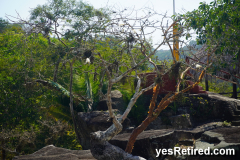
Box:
[0,0,153,158]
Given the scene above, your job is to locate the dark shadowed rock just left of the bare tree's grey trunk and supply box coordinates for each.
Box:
[77,110,130,149]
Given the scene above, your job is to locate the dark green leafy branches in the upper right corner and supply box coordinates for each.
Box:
[180,0,240,67]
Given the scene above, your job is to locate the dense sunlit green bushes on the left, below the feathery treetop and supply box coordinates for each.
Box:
[0,19,80,159]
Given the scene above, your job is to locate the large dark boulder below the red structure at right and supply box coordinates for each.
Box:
[147,92,240,130]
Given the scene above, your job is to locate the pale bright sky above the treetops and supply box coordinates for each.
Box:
[0,0,214,49]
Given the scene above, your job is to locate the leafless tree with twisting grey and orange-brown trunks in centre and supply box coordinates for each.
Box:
[71,8,214,160]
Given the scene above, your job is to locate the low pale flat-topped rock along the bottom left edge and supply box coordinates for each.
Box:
[13,145,96,160]
